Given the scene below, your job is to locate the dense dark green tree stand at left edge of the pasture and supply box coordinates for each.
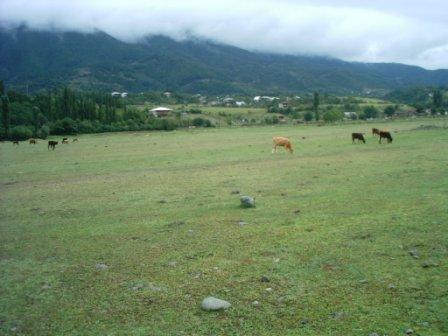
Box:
[0,81,185,140]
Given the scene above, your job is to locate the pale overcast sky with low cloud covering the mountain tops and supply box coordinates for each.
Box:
[0,0,448,69]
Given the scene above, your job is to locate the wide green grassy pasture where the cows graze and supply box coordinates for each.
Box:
[0,120,448,336]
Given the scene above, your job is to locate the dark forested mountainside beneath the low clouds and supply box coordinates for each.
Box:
[0,28,448,94]
